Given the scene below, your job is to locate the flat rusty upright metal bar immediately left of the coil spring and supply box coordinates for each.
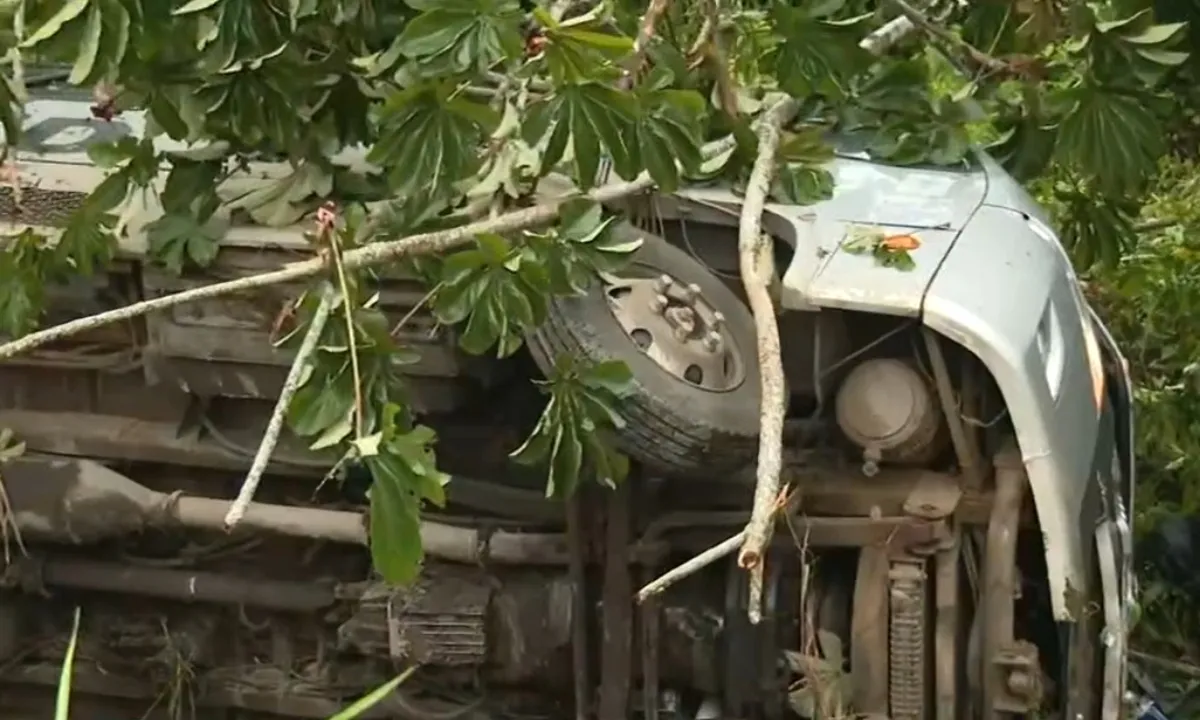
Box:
[850,546,890,716]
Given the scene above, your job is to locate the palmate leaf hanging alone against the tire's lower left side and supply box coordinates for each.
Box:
[511,354,632,497]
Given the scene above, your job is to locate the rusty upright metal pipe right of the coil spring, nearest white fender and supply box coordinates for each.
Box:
[980,450,1027,720]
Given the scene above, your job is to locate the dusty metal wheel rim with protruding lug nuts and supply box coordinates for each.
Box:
[605,265,745,392]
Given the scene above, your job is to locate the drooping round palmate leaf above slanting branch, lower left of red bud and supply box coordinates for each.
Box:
[367,86,500,197]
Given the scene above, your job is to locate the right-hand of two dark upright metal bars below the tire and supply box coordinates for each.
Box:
[598,480,637,720]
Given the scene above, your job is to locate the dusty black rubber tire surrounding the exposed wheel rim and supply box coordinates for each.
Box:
[529,224,760,476]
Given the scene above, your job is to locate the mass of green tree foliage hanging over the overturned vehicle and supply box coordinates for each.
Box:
[0,0,1186,580]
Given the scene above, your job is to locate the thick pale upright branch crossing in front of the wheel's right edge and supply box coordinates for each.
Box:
[738,98,797,624]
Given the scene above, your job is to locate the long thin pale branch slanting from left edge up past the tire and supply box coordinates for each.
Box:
[0,136,736,360]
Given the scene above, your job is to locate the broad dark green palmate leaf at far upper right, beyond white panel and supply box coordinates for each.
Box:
[1057,84,1164,196]
